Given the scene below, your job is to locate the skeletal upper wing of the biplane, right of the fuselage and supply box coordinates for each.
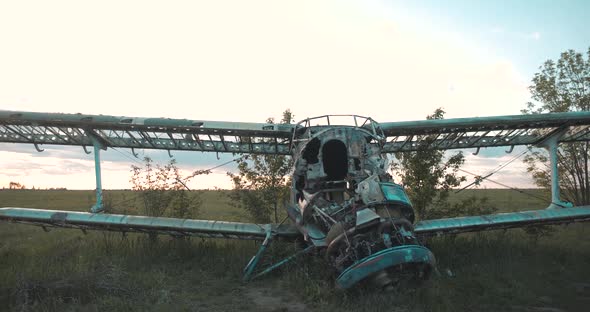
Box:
[380,112,590,153]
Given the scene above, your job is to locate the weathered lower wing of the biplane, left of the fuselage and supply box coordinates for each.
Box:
[0,207,300,240]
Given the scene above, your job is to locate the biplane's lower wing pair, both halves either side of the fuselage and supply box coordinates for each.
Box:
[0,206,590,240]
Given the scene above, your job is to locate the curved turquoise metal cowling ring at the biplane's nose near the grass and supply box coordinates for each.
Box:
[336,245,436,289]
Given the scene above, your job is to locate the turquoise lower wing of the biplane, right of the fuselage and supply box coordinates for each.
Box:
[414,206,590,236]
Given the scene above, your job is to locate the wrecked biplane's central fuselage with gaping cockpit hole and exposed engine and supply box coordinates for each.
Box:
[287,118,434,288]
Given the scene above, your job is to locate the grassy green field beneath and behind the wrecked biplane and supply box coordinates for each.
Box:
[0,190,590,311]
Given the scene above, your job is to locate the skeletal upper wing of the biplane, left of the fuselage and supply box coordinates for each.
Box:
[0,110,295,155]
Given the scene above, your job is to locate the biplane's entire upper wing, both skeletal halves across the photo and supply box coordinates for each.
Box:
[0,110,590,155]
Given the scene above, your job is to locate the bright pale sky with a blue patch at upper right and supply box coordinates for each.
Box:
[0,0,590,189]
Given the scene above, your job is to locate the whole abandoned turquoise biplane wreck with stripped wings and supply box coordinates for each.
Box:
[0,111,590,288]
